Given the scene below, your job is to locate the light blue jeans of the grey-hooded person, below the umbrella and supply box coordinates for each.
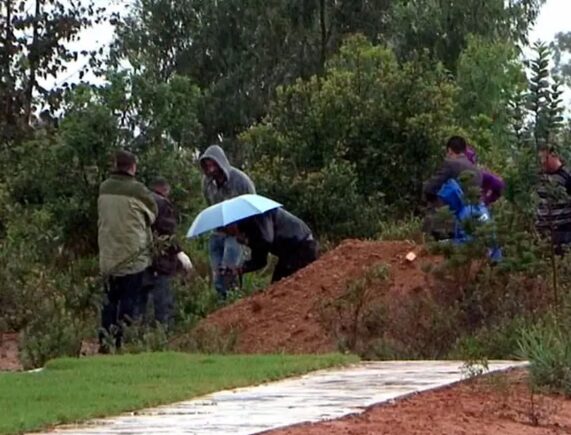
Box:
[209,233,244,299]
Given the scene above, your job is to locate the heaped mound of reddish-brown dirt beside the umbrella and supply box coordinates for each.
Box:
[197,240,438,353]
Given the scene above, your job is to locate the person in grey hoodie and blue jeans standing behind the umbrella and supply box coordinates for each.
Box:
[199,145,256,299]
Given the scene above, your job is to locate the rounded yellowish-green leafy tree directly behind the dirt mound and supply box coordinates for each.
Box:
[242,36,457,238]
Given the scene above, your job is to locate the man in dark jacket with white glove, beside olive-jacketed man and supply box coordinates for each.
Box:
[139,177,192,327]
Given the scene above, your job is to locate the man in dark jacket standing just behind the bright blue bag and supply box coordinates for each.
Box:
[423,136,482,239]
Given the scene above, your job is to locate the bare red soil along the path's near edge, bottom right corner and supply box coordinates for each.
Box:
[266,370,571,435]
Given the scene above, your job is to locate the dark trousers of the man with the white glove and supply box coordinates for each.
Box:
[138,269,174,327]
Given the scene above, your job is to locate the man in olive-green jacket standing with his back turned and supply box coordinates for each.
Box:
[97,150,157,353]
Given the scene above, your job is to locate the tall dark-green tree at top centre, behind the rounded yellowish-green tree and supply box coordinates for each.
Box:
[114,0,396,148]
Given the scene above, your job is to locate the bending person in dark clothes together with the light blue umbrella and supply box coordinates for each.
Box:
[187,195,319,283]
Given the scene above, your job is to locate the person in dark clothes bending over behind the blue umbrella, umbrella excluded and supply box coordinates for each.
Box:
[228,208,319,283]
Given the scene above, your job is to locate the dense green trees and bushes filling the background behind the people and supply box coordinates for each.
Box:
[0,0,571,378]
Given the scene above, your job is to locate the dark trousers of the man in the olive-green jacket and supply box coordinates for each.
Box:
[99,272,143,348]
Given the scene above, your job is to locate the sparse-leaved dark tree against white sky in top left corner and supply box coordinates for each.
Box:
[0,0,104,145]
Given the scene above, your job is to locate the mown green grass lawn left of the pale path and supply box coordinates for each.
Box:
[0,352,356,433]
